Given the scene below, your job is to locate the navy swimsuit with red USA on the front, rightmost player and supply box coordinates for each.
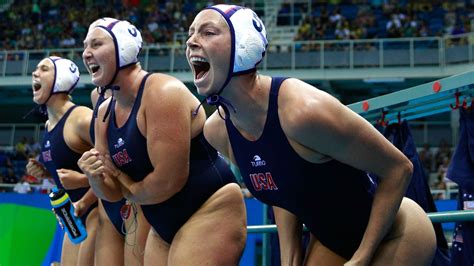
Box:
[226,78,375,259]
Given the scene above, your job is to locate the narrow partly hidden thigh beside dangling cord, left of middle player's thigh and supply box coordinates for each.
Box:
[124,204,150,265]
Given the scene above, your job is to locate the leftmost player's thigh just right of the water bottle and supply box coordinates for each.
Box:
[77,208,98,265]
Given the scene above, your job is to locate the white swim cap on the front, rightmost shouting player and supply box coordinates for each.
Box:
[207,5,268,76]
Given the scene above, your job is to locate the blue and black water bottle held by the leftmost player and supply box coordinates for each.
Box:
[49,188,87,245]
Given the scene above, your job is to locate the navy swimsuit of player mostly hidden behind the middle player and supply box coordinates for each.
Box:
[89,90,125,236]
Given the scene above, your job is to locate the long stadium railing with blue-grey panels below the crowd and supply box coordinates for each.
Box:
[0,33,474,77]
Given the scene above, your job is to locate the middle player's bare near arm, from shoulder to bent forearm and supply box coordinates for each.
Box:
[116,75,195,204]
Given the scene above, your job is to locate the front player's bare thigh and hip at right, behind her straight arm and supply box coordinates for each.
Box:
[372,198,436,266]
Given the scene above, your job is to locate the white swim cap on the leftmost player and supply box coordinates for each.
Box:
[48,56,80,94]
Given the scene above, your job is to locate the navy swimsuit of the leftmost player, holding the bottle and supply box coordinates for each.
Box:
[41,105,97,225]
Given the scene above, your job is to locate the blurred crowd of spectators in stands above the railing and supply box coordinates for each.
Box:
[0,0,474,49]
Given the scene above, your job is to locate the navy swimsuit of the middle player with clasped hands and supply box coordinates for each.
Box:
[107,74,235,243]
